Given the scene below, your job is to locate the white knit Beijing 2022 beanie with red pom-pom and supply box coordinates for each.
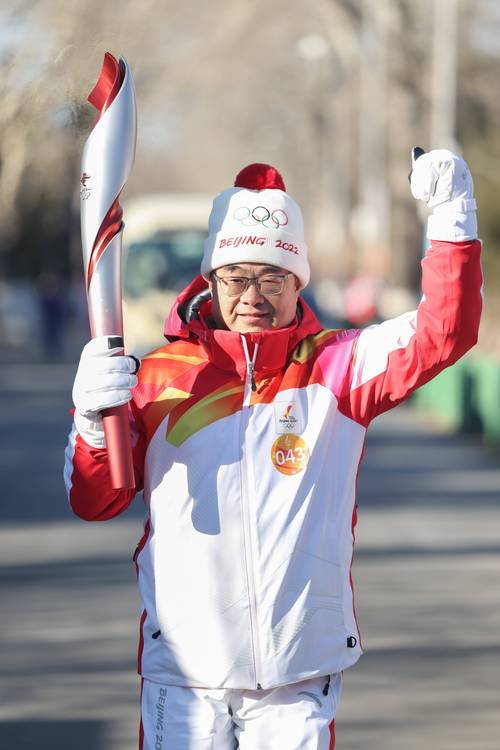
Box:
[201,164,310,288]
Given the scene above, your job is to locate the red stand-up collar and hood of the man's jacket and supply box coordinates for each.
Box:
[165,276,322,378]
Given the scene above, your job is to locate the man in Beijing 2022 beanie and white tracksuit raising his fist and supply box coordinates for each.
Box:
[65,150,481,750]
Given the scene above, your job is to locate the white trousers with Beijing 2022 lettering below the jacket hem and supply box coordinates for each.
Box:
[139,673,342,750]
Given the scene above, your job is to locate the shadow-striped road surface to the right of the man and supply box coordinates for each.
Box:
[336,407,500,750]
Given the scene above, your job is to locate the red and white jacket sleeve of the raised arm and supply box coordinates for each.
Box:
[339,240,482,426]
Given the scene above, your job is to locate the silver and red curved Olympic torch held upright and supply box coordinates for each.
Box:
[80,52,137,489]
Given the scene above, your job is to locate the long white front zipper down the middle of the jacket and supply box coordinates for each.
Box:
[240,335,261,690]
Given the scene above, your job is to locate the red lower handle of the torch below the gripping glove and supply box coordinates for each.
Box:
[103,404,135,490]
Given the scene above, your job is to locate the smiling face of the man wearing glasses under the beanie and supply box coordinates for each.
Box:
[208,263,299,333]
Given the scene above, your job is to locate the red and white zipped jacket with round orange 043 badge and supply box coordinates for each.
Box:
[65,241,482,689]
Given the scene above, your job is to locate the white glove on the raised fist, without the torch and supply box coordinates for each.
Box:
[410,148,477,242]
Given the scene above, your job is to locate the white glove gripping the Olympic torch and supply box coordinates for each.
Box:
[73,336,140,448]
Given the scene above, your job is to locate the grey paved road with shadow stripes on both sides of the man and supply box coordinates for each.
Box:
[0,364,500,750]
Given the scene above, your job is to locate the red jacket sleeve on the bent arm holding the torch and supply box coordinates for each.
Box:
[64,402,145,521]
